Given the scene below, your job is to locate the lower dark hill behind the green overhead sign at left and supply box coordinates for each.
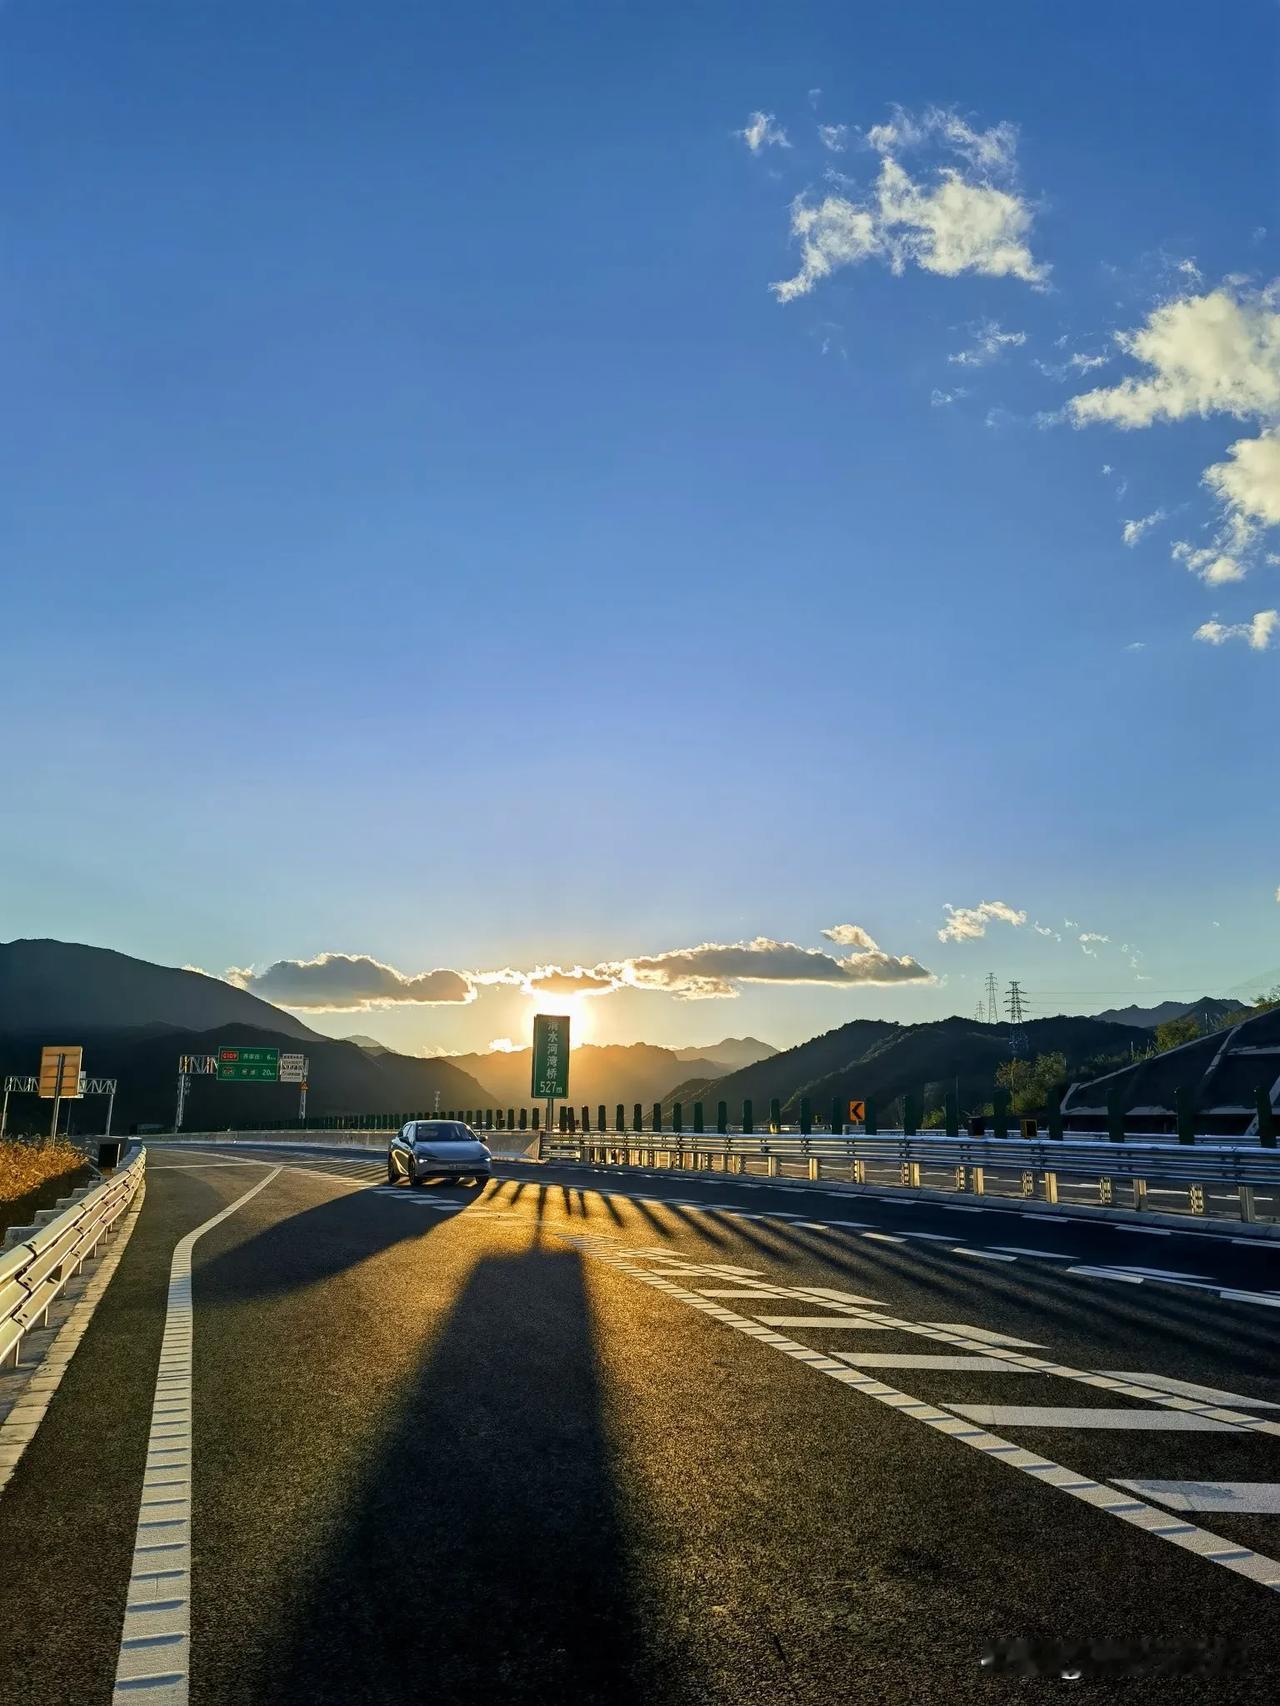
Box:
[0,1003,497,1131]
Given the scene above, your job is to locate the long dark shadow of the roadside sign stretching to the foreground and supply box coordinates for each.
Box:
[205,1241,655,1706]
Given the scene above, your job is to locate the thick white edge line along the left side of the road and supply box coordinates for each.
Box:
[111,1167,282,1706]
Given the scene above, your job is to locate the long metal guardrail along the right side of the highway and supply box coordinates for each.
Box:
[556,1133,1280,1221]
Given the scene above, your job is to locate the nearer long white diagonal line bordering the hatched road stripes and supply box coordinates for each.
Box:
[570,1233,1280,1590]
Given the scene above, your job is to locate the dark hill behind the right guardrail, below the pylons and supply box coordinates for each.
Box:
[672,1015,1150,1123]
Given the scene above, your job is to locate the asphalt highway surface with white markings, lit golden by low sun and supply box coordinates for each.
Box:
[0,1143,1280,1706]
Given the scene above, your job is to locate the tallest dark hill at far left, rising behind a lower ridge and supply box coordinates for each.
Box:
[0,937,316,1042]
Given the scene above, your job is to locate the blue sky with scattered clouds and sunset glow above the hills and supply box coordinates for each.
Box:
[0,0,1280,1049]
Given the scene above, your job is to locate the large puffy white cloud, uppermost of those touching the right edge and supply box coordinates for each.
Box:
[1068,287,1280,427]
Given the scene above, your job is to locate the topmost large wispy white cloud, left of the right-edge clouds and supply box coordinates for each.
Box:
[771,109,1048,302]
